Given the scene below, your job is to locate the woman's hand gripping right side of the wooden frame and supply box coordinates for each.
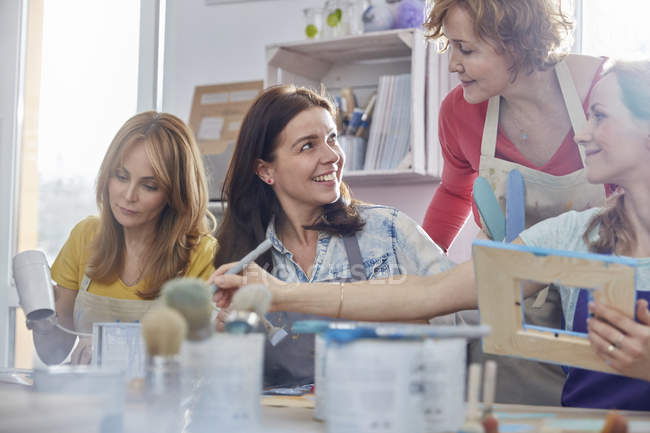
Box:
[587,299,650,381]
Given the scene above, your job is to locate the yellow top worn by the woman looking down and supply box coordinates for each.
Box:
[51,217,217,300]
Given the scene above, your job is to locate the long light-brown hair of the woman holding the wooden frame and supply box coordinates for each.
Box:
[583,61,650,255]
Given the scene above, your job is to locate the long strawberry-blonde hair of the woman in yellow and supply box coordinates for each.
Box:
[88,111,215,299]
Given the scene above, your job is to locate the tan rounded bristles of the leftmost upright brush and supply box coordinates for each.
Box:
[141,306,187,357]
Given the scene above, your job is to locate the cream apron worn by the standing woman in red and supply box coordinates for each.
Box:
[470,62,605,405]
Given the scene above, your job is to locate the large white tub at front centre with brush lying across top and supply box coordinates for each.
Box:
[325,339,426,433]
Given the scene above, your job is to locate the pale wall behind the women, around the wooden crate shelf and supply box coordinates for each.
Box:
[163,0,473,260]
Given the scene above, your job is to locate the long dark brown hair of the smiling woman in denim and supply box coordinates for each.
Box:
[214,85,364,270]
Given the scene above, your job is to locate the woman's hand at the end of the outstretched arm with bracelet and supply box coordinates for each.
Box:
[208,262,281,308]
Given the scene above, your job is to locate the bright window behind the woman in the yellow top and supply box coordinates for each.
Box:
[14,0,164,368]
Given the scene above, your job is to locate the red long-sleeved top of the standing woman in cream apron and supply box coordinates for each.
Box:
[422,61,610,250]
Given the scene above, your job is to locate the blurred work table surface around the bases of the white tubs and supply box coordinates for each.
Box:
[0,384,650,433]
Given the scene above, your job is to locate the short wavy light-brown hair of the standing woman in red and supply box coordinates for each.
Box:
[424,0,573,79]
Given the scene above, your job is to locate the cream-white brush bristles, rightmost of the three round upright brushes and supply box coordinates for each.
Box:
[226,284,288,346]
